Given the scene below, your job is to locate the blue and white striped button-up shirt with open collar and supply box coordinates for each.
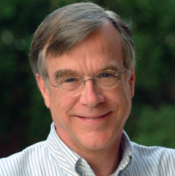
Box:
[0,123,175,176]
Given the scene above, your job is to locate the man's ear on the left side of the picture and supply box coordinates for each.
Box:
[36,73,50,108]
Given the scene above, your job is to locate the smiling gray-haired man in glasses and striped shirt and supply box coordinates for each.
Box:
[0,3,175,176]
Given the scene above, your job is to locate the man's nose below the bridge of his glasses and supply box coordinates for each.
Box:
[80,79,105,107]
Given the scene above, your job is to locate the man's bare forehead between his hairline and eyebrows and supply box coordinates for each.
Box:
[47,23,124,75]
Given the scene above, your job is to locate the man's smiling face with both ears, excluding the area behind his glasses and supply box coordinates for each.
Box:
[37,24,135,152]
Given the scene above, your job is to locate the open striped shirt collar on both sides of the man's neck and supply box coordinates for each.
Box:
[47,123,133,176]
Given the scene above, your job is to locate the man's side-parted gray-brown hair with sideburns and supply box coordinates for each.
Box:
[30,3,135,80]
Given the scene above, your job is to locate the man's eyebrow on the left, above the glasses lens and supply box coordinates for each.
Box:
[54,69,77,79]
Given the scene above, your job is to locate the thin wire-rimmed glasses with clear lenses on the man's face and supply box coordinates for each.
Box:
[49,68,125,97]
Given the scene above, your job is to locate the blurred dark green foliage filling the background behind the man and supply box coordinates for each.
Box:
[0,0,175,157]
